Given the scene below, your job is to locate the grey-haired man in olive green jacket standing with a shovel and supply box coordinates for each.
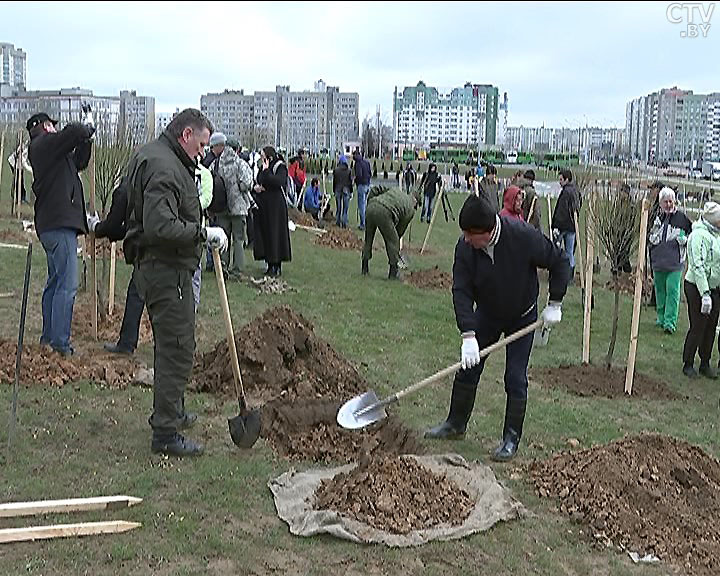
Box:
[123,108,227,456]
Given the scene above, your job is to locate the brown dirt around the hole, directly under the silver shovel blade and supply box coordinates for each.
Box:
[261,397,423,463]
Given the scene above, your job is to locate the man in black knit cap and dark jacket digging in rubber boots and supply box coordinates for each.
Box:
[425,195,569,461]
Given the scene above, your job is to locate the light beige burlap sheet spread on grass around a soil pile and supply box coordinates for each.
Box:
[268,454,527,547]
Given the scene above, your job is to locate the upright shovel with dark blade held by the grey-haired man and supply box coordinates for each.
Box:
[213,248,260,448]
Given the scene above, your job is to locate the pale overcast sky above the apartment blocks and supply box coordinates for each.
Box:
[0,2,720,127]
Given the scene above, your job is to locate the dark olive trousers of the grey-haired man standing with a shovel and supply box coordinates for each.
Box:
[134,260,195,437]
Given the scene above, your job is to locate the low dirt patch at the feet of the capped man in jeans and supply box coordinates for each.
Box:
[0,339,137,388]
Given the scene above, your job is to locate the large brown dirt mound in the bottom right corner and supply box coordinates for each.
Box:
[528,434,720,576]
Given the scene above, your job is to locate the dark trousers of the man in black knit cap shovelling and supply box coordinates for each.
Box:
[448,304,537,429]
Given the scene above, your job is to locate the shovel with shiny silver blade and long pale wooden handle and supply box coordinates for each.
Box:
[337,318,547,430]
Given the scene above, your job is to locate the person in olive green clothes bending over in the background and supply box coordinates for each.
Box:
[362,186,417,279]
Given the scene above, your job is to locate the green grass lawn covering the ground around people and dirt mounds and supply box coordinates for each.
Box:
[0,188,720,576]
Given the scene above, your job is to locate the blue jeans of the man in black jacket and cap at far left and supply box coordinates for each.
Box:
[39,228,77,352]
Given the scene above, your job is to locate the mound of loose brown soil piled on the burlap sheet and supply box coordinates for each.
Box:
[315,456,473,534]
